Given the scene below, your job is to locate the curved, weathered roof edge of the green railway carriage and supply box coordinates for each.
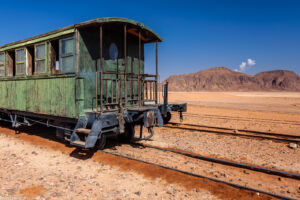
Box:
[0,17,163,51]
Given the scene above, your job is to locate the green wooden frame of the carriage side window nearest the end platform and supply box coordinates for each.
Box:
[59,35,76,74]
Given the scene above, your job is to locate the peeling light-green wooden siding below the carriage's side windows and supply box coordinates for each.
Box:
[0,77,77,118]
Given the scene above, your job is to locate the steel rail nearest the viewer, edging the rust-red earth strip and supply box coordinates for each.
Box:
[100,150,295,200]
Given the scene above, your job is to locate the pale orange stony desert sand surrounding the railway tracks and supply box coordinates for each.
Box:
[0,92,300,200]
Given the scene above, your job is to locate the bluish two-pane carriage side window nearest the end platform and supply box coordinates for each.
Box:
[60,37,75,73]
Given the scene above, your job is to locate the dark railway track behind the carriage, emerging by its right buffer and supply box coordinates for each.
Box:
[164,122,300,143]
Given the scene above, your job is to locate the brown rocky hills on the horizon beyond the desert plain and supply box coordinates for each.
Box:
[164,67,300,91]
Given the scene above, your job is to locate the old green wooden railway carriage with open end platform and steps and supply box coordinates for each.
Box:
[0,18,185,148]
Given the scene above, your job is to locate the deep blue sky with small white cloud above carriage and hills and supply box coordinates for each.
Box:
[0,0,300,80]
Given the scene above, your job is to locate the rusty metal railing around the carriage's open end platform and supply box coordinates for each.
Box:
[92,72,158,112]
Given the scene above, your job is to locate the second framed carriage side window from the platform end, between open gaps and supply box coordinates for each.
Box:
[35,43,47,74]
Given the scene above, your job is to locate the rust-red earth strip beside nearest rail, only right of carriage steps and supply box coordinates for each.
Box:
[93,153,273,200]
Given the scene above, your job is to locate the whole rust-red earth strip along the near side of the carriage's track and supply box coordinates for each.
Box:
[0,128,274,199]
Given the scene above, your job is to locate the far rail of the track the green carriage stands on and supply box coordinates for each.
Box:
[133,143,300,180]
